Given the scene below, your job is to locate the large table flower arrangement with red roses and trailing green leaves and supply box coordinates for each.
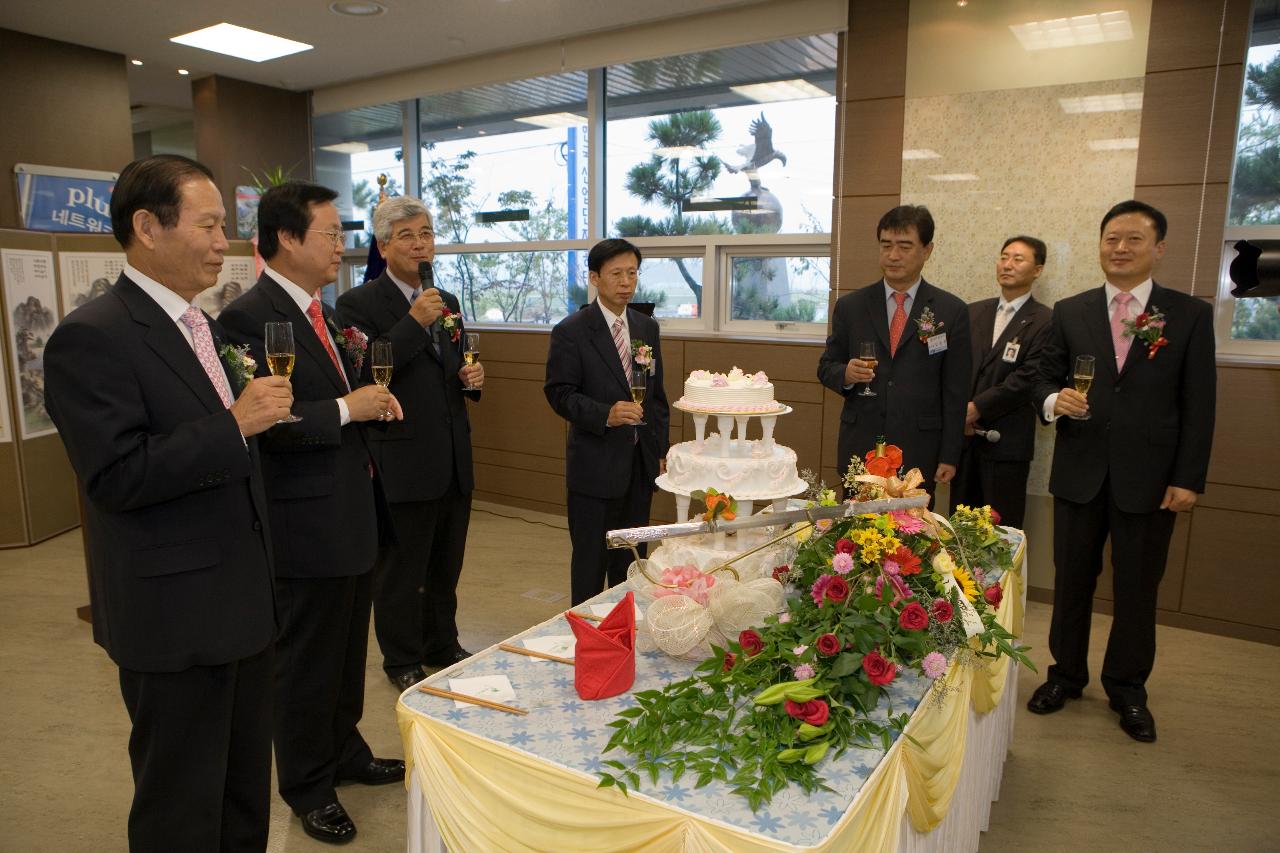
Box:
[599,448,1030,809]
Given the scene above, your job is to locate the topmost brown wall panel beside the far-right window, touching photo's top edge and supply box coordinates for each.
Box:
[1147,0,1252,74]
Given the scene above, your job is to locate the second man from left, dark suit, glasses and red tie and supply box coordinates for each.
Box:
[219,182,404,843]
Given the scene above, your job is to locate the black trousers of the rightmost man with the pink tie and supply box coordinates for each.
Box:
[1048,478,1176,706]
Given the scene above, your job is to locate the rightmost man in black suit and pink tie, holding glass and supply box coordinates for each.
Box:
[1027,201,1216,742]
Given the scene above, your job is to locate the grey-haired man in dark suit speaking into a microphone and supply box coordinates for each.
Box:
[337,196,484,690]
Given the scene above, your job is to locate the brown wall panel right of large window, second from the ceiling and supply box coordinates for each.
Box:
[840,97,906,196]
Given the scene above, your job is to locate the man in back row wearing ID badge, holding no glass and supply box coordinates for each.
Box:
[951,236,1052,528]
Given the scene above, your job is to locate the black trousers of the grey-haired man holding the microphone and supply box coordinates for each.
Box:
[374,479,471,678]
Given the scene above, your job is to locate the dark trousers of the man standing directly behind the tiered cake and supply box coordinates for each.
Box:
[567,444,653,606]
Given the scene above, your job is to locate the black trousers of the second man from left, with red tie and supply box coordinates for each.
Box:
[274,571,374,815]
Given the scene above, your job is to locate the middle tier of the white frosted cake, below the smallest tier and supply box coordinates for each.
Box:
[659,433,808,501]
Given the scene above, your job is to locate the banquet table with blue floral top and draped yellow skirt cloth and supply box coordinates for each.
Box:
[397,529,1027,853]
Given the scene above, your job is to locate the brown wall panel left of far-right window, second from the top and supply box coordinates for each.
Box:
[1134,64,1244,186]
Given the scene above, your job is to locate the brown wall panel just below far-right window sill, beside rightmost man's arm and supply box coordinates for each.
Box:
[1208,366,1280,489]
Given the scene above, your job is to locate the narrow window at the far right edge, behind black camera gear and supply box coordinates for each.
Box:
[1217,3,1280,359]
